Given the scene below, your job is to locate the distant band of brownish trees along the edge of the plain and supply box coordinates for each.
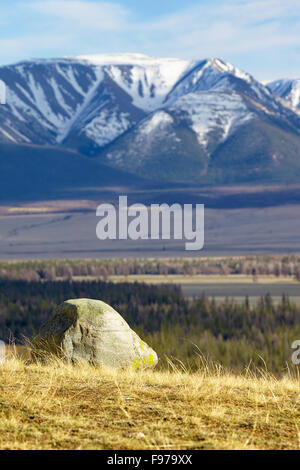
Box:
[0,255,300,281]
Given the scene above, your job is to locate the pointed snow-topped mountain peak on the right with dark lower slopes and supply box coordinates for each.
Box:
[101,59,300,182]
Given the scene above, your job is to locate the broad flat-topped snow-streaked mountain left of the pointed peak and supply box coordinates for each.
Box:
[0,54,191,147]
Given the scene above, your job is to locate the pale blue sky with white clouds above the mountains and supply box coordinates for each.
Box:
[0,0,300,81]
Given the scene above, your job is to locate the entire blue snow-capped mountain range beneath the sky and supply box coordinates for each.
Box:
[0,54,300,182]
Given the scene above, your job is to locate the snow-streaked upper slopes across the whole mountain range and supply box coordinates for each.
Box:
[0,54,300,160]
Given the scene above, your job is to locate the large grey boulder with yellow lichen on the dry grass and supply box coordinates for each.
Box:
[32,299,158,369]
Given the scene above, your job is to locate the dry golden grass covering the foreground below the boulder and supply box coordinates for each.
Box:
[0,358,300,450]
